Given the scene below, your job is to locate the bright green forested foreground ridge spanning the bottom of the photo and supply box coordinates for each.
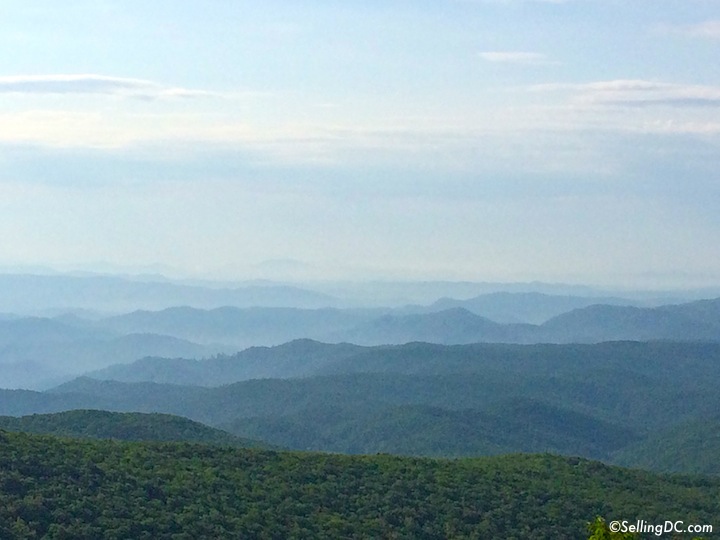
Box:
[0,432,720,540]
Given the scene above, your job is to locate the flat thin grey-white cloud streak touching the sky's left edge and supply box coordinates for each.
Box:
[0,74,211,99]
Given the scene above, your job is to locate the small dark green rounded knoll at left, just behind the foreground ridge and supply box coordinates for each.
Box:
[0,410,267,448]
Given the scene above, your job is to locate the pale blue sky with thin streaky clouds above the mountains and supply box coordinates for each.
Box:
[0,0,720,287]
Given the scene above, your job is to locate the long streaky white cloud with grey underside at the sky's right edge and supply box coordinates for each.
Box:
[531,79,720,107]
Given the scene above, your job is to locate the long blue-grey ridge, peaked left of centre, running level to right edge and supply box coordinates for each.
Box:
[84,340,720,392]
